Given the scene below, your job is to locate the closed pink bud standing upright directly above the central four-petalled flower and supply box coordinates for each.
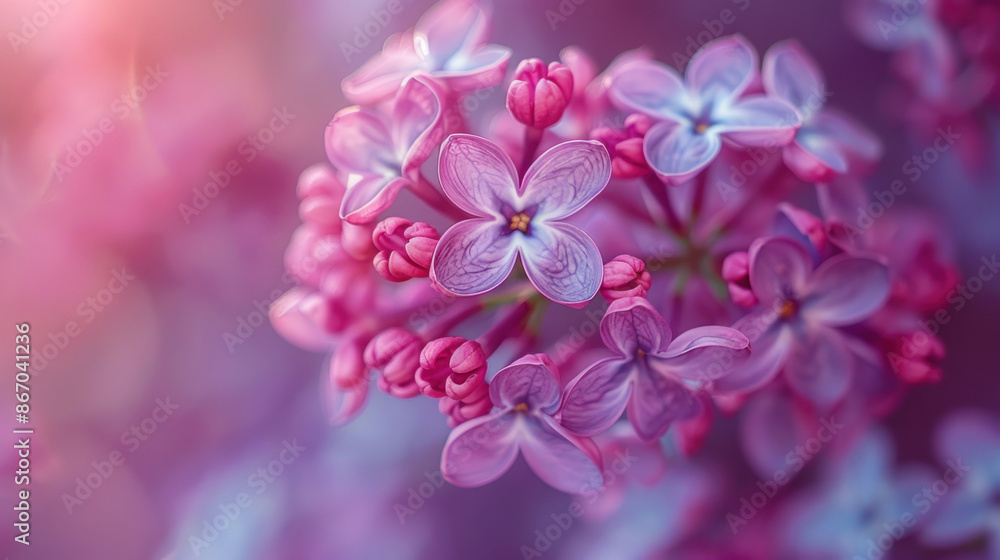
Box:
[507,58,573,129]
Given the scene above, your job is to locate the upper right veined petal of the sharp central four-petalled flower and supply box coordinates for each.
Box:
[521,140,611,220]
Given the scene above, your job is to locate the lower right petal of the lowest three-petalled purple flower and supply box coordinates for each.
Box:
[520,415,604,494]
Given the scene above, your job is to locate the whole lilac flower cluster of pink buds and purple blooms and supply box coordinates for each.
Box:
[271,0,957,493]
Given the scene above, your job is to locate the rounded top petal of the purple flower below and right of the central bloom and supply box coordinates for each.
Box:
[601,297,673,358]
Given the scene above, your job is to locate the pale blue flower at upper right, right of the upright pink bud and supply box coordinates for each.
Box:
[609,36,799,185]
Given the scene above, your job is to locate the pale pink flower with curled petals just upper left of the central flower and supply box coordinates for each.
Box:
[326,78,442,224]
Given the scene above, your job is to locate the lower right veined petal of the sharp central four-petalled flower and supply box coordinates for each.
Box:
[520,222,604,307]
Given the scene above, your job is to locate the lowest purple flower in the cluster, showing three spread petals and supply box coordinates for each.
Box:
[441,354,603,493]
